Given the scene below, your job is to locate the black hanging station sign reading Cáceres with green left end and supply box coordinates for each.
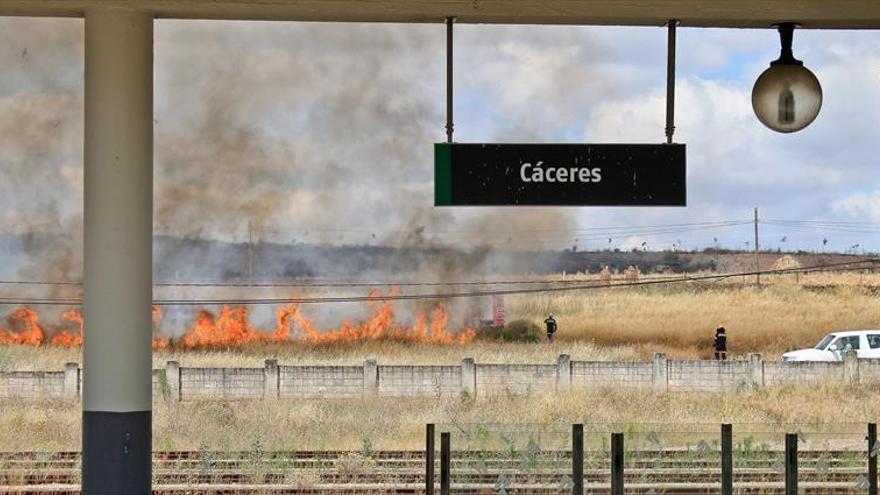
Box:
[434,143,687,206]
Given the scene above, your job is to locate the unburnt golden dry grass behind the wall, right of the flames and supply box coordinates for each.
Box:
[508,278,880,359]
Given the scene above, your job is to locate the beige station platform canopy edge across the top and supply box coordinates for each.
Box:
[0,0,880,29]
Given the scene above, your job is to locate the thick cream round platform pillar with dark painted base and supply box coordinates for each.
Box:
[82,8,153,495]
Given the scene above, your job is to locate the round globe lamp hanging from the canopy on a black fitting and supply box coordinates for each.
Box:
[752,22,822,133]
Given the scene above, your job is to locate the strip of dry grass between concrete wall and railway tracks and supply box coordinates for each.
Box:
[0,384,880,451]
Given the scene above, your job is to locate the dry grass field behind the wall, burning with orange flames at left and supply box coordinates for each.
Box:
[0,273,880,369]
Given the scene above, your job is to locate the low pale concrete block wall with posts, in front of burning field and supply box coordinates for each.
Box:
[0,353,880,401]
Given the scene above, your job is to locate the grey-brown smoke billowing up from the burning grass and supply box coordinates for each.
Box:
[0,19,614,338]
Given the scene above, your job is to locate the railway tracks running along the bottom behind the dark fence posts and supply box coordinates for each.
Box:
[0,450,867,495]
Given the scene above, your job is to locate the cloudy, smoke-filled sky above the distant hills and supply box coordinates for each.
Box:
[0,19,880,252]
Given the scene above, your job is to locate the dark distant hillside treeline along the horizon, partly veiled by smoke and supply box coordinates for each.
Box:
[0,235,861,282]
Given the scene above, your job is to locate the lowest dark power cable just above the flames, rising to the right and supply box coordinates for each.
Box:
[0,258,880,306]
